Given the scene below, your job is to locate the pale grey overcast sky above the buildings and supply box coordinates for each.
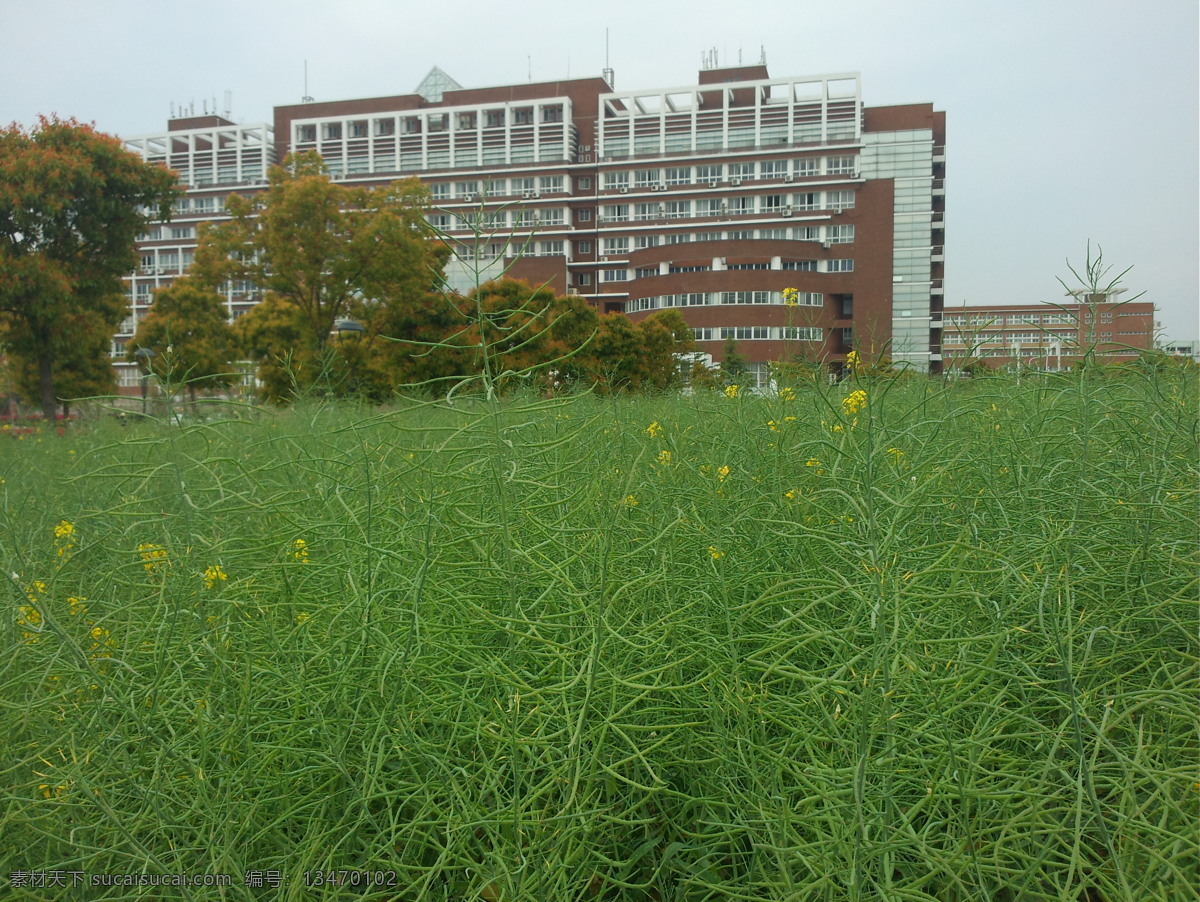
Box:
[0,0,1200,339]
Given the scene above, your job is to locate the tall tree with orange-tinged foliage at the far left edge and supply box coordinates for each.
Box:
[0,116,179,417]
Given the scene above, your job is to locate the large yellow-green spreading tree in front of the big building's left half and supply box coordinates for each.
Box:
[193,152,448,397]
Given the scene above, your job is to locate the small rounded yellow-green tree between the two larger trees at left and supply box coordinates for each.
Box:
[126,276,238,403]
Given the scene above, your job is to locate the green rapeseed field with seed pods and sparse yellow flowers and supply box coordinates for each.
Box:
[0,362,1200,902]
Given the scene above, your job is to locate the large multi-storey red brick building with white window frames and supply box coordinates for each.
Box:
[114,65,946,380]
